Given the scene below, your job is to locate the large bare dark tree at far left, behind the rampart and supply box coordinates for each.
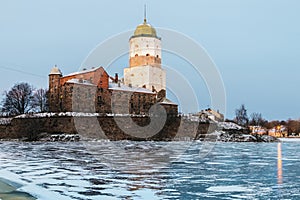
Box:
[2,83,34,115]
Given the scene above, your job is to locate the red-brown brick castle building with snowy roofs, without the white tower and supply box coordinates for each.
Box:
[49,66,178,115]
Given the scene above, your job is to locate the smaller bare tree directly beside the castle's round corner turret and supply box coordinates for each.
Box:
[33,88,48,112]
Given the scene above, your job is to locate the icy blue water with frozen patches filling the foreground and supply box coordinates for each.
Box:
[0,140,300,200]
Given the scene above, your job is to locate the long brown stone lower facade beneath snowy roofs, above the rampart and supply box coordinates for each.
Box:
[50,79,156,114]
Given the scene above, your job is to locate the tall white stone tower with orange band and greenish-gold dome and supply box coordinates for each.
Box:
[124,17,166,92]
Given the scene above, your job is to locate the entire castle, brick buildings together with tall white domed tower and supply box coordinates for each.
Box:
[49,18,178,115]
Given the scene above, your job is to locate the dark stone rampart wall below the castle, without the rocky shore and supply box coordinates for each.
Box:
[0,116,216,141]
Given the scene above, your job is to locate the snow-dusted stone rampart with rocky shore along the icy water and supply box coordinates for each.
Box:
[0,113,278,142]
